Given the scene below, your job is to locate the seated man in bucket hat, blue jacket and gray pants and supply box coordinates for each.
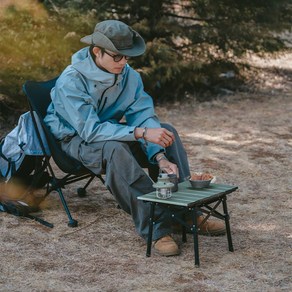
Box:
[45,20,225,256]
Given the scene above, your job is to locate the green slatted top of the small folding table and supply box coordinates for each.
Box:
[138,181,238,207]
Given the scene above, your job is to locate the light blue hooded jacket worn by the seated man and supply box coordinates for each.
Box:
[45,47,163,161]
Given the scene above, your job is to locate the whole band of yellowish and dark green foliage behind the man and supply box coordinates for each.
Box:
[0,0,292,107]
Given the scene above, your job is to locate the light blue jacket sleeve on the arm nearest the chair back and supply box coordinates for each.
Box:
[52,75,135,143]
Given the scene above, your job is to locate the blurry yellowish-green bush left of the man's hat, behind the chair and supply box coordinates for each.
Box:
[0,6,96,108]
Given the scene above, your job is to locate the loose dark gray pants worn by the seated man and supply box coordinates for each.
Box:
[61,124,190,240]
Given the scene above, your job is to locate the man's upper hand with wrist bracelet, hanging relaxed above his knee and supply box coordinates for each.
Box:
[135,128,174,148]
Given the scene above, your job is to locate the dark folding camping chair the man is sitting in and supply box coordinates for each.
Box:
[23,78,104,227]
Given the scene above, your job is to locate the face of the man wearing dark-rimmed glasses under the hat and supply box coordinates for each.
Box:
[93,47,128,74]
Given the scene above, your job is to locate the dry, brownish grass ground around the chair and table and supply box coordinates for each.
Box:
[0,54,292,291]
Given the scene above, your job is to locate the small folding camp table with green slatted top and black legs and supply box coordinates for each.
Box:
[138,181,238,267]
